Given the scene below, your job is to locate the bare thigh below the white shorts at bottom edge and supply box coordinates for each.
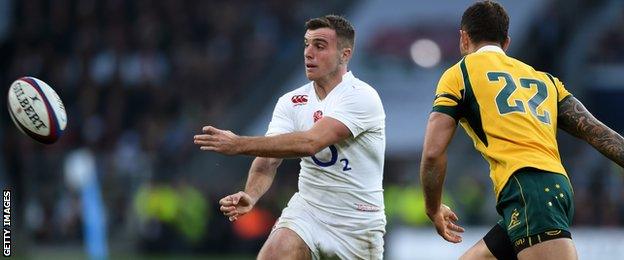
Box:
[258,228,312,260]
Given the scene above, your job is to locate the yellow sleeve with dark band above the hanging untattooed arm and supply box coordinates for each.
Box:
[433,65,464,120]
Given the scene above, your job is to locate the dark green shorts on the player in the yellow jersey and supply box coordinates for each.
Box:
[496,168,574,247]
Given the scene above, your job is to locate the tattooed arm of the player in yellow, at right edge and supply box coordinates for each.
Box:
[557,97,624,167]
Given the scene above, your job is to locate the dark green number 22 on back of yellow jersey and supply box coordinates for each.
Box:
[487,72,551,125]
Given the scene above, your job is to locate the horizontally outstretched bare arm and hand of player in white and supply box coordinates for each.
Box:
[195,117,351,158]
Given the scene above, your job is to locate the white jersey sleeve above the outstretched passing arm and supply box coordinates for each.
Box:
[325,88,386,137]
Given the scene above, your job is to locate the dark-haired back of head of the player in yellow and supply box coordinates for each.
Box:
[461,0,509,45]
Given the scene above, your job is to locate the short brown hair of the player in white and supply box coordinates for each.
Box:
[305,14,355,49]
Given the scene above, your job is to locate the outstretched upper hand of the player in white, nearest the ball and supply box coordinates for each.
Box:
[193,126,239,155]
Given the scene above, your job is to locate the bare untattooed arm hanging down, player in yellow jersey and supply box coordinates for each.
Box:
[420,112,464,243]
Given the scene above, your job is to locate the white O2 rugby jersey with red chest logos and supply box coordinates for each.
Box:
[266,72,386,226]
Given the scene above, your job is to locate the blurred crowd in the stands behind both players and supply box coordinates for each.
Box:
[0,0,624,252]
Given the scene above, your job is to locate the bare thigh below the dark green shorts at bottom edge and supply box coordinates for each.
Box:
[518,238,578,260]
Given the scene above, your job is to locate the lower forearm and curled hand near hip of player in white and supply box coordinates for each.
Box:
[219,157,282,221]
